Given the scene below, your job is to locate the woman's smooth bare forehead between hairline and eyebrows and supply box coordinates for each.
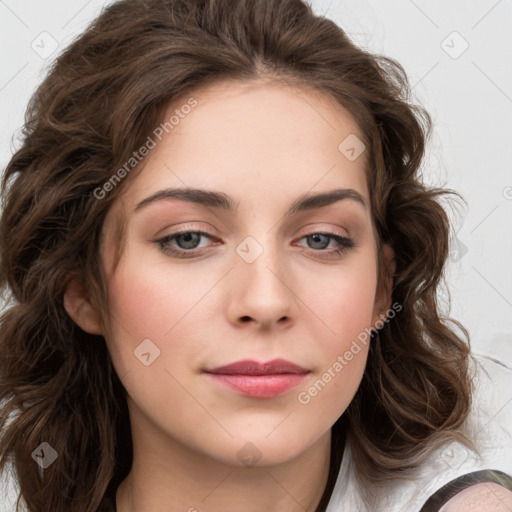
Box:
[115,80,367,216]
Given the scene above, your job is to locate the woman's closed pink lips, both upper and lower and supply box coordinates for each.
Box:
[205,359,310,398]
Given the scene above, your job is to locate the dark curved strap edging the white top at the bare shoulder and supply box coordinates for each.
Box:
[420,469,512,512]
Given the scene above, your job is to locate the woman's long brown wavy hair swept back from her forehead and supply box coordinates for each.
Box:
[0,0,473,512]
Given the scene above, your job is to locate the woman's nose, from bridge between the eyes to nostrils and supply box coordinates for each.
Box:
[228,238,296,329]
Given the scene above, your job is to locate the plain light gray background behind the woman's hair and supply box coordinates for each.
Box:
[0,0,512,508]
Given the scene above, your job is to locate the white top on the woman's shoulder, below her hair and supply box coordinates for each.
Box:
[327,354,512,512]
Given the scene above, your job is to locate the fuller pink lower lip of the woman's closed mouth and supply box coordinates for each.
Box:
[207,373,307,398]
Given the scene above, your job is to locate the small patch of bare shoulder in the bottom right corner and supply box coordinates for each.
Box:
[439,482,512,512]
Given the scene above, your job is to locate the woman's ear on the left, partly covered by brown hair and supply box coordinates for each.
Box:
[64,275,103,335]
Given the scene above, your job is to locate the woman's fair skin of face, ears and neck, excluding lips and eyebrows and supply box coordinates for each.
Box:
[64,80,394,512]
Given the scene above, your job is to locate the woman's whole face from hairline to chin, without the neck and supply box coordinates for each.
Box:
[102,82,391,465]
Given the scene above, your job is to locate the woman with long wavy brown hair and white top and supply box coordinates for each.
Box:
[0,0,512,512]
